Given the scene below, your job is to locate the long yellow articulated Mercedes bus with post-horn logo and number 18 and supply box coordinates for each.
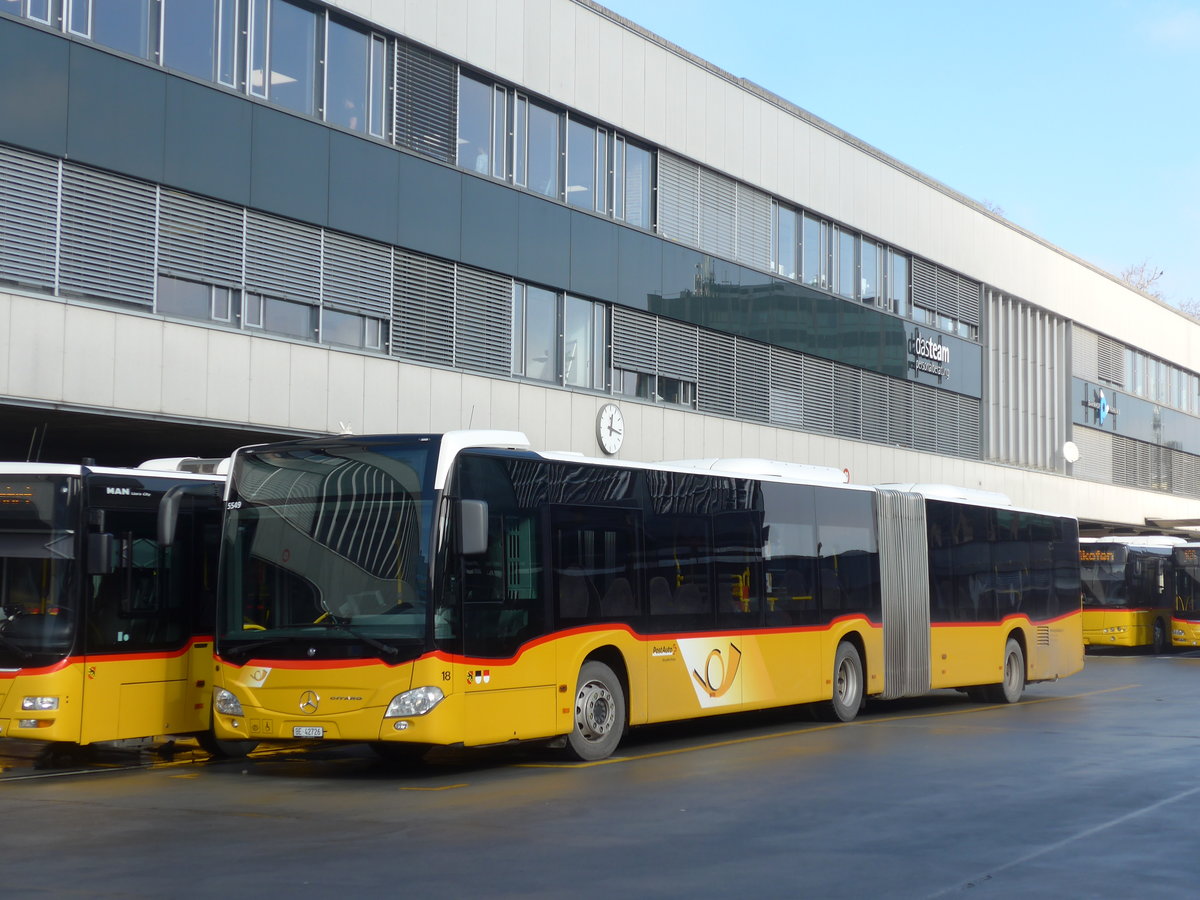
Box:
[214,432,1084,760]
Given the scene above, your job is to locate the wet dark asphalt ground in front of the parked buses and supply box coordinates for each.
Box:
[0,653,1200,900]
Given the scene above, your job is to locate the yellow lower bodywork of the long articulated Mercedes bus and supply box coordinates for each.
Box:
[214,613,1084,746]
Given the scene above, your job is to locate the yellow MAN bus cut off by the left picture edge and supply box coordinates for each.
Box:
[0,460,248,755]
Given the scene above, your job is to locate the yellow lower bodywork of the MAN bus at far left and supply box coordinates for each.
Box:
[0,638,212,744]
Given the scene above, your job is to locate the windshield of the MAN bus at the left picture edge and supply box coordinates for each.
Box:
[0,474,79,668]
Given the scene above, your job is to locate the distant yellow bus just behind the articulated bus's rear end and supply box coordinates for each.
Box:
[1079,535,1183,653]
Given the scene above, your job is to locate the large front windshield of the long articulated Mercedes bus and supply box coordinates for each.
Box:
[217,440,437,661]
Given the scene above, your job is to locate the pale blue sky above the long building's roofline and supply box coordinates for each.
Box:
[600,0,1200,304]
